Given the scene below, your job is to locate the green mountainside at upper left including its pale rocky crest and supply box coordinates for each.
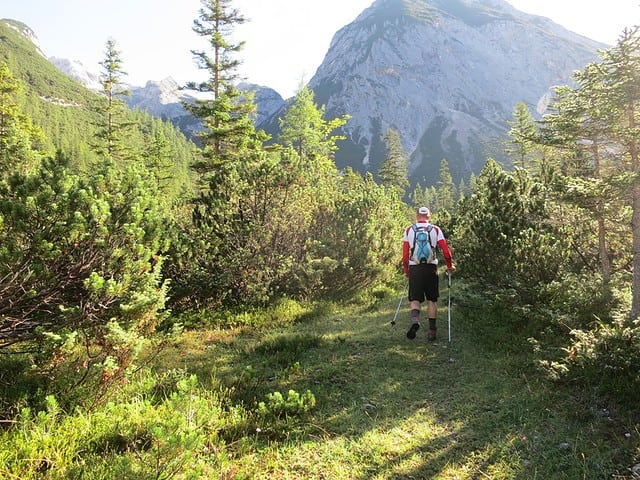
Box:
[0,19,198,192]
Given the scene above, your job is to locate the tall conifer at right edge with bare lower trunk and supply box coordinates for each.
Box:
[542,29,640,296]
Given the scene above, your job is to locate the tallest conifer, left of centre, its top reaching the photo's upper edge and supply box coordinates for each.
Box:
[173,0,270,304]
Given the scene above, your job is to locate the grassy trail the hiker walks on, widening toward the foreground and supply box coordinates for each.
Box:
[172,286,639,480]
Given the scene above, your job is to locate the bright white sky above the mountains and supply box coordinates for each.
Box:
[0,0,640,98]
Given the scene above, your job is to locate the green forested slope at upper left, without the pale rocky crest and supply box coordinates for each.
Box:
[0,24,194,199]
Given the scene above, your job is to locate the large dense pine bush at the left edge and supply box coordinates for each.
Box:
[0,156,166,398]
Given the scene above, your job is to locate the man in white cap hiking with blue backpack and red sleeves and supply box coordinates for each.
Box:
[402,207,455,341]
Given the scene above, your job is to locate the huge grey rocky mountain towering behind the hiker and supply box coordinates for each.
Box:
[310,0,605,185]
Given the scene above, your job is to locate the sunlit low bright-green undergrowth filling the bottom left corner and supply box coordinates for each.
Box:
[0,376,235,480]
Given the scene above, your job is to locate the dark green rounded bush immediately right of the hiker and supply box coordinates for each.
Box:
[453,160,561,302]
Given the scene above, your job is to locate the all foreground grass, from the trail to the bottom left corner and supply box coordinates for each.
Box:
[0,284,640,480]
